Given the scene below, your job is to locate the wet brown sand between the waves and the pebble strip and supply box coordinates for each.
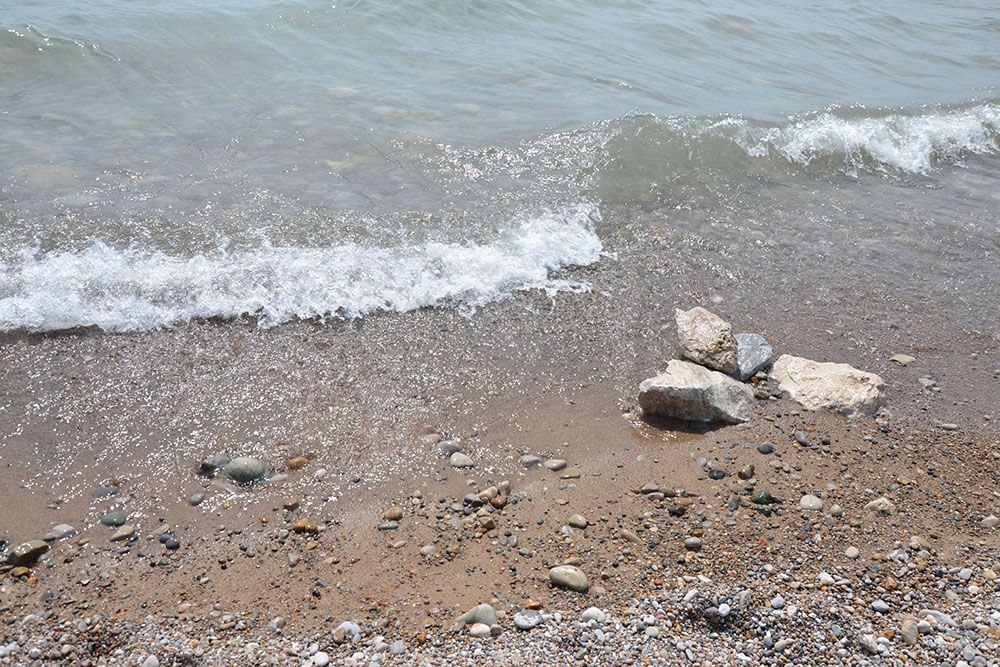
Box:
[0,173,1000,664]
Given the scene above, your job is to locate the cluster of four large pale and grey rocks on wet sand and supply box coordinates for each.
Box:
[638,307,884,424]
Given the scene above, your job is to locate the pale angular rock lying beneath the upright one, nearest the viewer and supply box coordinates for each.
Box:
[639,359,754,424]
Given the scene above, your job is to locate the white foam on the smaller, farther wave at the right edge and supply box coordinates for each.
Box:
[739,104,1000,174]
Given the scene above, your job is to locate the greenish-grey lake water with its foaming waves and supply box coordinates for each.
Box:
[0,0,1000,331]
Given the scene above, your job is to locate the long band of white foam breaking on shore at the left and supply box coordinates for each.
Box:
[0,203,602,331]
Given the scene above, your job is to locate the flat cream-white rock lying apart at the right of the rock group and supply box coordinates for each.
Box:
[771,354,885,415]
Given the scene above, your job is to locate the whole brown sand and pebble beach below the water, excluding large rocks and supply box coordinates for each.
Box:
[0,175,1000,667]
